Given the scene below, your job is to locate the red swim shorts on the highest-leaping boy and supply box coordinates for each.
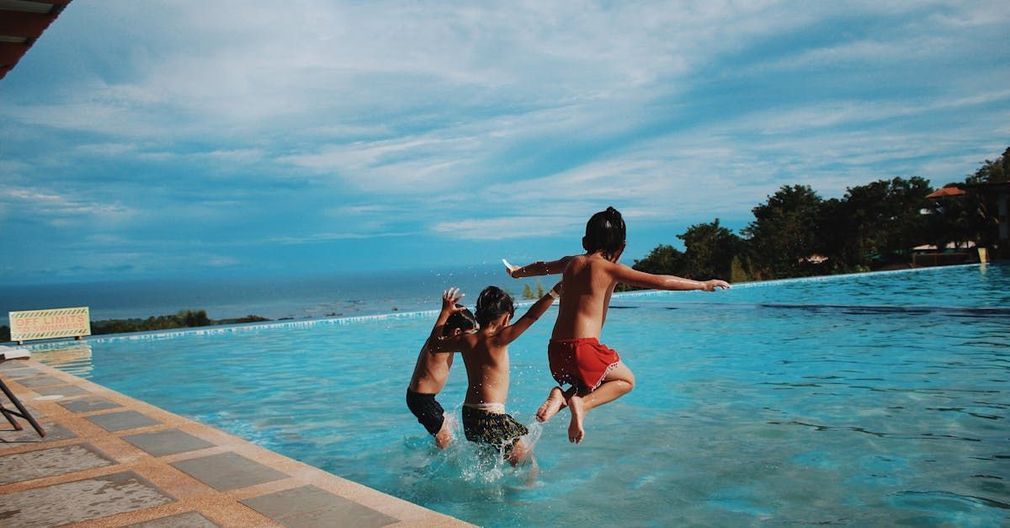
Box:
[547,337,621,391]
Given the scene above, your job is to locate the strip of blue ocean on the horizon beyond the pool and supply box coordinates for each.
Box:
[0,265,553,324]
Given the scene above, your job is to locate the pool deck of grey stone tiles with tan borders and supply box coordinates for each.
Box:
[0,359,471,528]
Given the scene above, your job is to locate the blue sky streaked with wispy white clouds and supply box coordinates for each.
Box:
[0,0,1010,284]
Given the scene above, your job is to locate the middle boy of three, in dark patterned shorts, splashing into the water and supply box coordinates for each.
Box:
[432,284,561,465]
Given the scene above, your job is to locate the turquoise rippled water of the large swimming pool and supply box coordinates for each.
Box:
[27,265,1010,526]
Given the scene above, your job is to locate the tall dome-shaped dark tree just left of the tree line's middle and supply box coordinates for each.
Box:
[743,185,822,279]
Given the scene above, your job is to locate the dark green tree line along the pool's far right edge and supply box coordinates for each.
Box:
[633,147,1010,283]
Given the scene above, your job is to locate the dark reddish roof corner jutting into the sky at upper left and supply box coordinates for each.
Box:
[0,0,71,79]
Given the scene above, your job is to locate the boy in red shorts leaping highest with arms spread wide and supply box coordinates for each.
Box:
[505,207,729,443]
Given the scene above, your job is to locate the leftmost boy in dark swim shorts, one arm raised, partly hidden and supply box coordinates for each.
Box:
[407,288,477,449]
